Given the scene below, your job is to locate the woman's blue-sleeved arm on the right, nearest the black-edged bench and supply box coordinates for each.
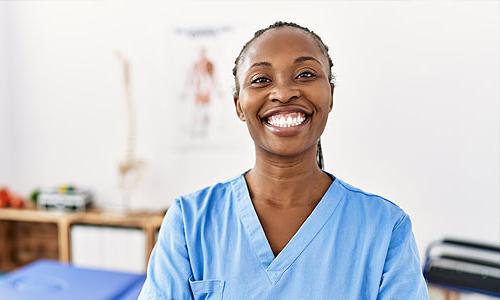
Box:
[377,214,429,300]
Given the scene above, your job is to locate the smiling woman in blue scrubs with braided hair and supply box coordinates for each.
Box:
[140,22,428,299]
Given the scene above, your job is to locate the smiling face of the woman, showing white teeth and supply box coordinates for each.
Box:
[234,27,333,156]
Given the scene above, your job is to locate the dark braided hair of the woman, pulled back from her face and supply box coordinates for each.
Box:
[233,21,335,170]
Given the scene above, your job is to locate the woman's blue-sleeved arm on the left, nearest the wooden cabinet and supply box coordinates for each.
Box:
[139,200,192,300]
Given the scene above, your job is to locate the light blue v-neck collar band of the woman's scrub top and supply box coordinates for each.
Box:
[231,173,343,285]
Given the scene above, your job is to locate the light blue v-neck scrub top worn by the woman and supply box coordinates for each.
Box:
[139,175,428,300]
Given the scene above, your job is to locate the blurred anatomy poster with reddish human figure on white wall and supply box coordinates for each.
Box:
[169,26,241,151]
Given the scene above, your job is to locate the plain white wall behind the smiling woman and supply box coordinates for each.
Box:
[0,1,500,260]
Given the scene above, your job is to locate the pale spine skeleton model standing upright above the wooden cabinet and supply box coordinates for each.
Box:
[116,52,144,210]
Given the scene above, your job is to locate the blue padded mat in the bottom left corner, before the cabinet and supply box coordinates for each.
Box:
[0,260,145,300]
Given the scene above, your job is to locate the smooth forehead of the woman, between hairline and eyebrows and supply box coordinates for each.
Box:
[241,27,328,71]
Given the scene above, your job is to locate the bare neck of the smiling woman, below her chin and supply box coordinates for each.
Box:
[245,149,332,208]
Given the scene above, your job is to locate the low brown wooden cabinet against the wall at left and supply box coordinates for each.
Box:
[0,208,164,272]
